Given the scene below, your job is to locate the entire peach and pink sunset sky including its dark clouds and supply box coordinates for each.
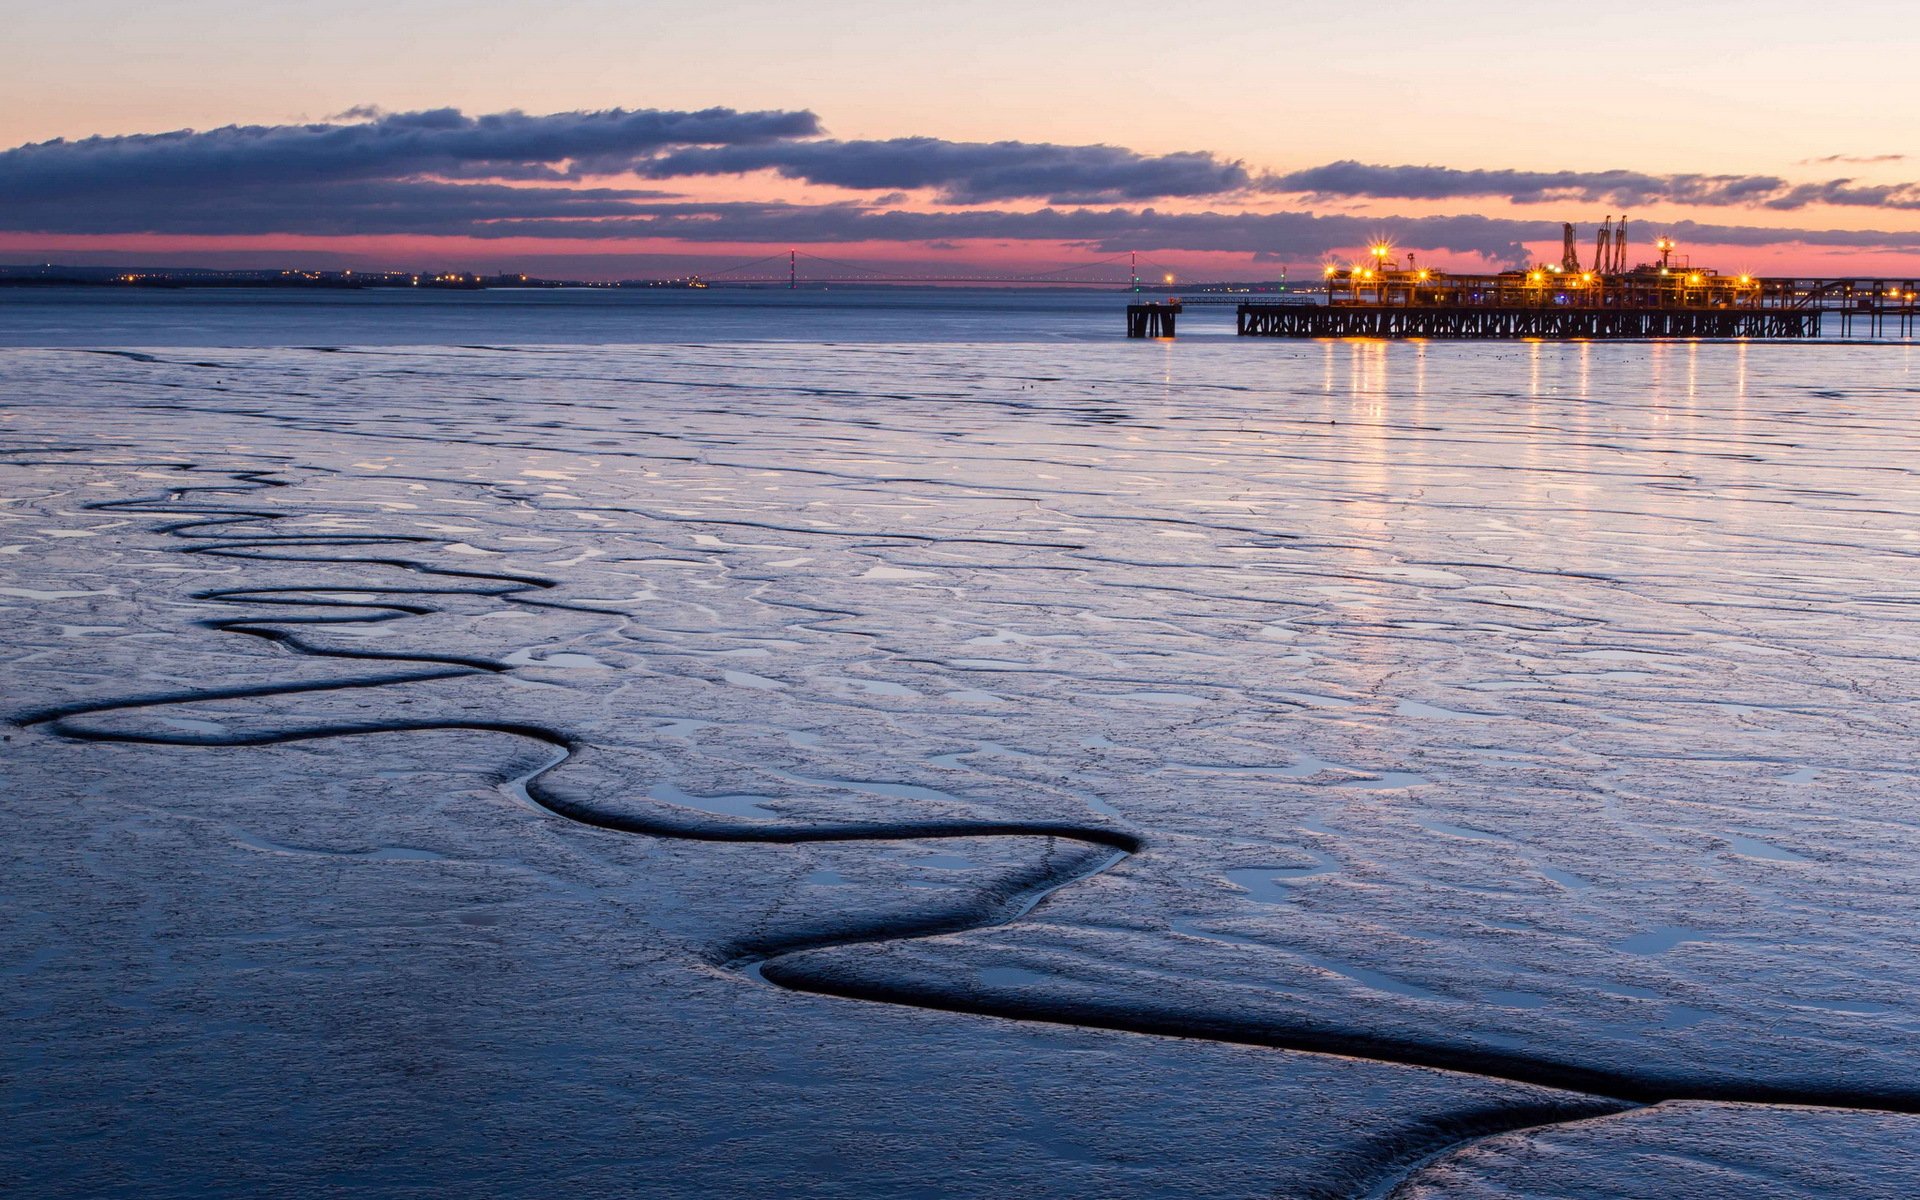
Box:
[0,0,1920,278]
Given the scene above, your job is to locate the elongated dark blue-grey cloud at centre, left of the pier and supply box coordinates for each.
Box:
[643,138,1252,204]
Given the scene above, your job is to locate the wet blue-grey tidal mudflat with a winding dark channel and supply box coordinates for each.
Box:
[0,342,1920,1198]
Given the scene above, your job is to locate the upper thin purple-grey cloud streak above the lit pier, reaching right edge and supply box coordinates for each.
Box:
[1260,159,1920,209]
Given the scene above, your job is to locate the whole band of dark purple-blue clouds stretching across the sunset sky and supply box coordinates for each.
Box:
[0,108,1920,261]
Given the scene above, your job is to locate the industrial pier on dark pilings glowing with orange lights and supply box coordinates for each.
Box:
[1213,217,1920,340]
